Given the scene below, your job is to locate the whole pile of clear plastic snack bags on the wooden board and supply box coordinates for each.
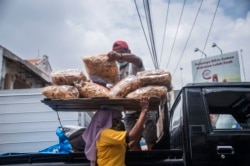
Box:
[42,54,172,102]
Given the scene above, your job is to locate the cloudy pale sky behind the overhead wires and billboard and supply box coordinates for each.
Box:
[0,0,250,89]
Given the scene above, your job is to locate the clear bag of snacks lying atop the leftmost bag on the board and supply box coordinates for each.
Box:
[50,69,87,85]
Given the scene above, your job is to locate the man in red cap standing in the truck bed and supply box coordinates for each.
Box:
[108,40,157,150]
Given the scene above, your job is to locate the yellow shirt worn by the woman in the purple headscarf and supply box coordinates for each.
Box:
[96,129,126,166]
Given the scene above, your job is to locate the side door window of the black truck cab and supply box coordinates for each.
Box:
[205,89,250,130]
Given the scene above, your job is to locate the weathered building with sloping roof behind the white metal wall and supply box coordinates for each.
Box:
[0,46,52,89]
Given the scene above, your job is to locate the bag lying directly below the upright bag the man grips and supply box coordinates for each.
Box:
[75,82,110,98]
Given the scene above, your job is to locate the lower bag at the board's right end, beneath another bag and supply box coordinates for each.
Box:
[126,85,167,103]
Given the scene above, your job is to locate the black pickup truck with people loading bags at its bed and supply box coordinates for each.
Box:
[0,82,250,166]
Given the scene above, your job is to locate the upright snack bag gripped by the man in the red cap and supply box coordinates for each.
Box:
[82,54,119,85]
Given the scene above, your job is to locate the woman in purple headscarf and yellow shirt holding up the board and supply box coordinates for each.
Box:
[83,97,149,166]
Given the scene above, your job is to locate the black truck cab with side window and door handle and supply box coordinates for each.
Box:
[169,82,250,166]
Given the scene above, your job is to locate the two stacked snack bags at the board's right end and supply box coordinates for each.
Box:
[110,70,172,103]
